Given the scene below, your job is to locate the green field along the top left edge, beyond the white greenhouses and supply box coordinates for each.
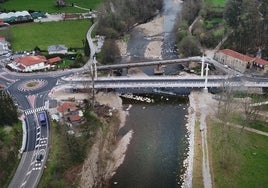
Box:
[0,0,102,13]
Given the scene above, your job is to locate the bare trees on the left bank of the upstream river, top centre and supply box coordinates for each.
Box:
[97,0,162,39]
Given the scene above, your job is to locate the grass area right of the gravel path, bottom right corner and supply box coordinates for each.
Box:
[209,120,268,188]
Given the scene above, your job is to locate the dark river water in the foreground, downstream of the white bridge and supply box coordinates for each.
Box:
[110,96,187,188]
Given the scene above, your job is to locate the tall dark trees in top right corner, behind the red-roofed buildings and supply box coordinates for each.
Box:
[223,0,268,59]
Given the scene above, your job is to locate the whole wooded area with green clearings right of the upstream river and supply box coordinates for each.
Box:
[176,0,268,59]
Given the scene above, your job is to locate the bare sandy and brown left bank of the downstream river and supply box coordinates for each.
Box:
[50,87,133,187]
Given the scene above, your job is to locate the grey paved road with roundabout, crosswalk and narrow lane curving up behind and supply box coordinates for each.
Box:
[6,20,96,188]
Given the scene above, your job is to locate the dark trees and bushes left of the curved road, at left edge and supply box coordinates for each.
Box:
[0,90,22,187]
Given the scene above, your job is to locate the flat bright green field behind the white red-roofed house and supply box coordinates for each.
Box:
[4,20,91,51]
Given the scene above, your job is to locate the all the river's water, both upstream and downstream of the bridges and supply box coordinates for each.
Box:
[110,0,188,188]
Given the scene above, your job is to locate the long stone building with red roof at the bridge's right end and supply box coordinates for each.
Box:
[214,49,255,73]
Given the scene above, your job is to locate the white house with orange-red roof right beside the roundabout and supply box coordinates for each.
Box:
[8,55,49,72]
